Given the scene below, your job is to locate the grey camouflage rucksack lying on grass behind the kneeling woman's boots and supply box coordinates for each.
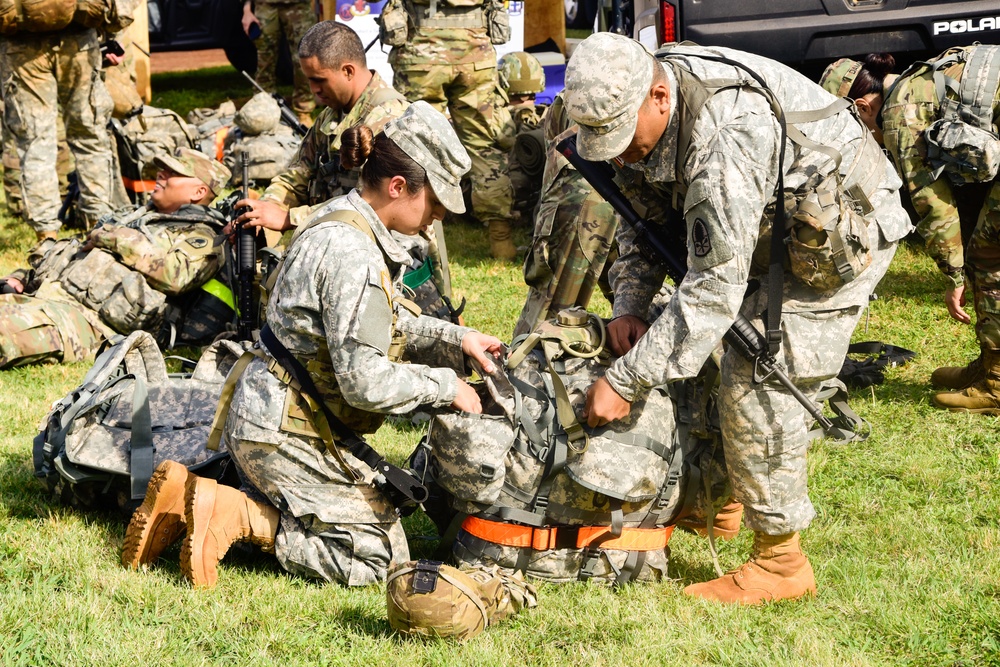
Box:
[33,331,243,512]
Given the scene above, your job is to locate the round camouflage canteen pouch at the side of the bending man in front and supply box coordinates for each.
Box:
[788,187,872,292]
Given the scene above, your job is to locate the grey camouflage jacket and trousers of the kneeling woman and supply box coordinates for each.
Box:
[225,190,469,586]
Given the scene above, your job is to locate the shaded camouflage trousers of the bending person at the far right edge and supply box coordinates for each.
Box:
[965,182,1000,350]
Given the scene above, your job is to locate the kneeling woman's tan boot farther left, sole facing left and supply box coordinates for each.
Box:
[122,461,193,569]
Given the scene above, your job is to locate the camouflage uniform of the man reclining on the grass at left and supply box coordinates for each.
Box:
[0,205,226,368]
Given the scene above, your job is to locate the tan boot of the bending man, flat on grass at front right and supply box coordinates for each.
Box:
[684,533,816,604]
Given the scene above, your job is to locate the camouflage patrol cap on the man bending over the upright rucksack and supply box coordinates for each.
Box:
[563,32,655,160]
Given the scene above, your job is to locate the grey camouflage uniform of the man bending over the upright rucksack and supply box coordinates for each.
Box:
[564,35,910,535]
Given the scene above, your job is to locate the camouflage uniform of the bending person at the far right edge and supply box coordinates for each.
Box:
[882,47,1000,350]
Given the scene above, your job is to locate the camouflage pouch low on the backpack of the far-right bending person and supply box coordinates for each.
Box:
[924,118,1000,185]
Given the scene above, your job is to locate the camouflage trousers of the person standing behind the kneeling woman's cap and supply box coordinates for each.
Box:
[392,61,514,223]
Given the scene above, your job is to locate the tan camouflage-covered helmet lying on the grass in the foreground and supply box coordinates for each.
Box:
[386,560,538,641]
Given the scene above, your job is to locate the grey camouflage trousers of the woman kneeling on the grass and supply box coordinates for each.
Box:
[226,412,410,586]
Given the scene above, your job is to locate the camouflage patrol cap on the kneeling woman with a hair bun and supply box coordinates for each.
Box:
[382,100,472,213]
